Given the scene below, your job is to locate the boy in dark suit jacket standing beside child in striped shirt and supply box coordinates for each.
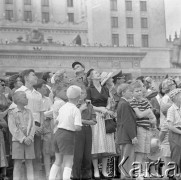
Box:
[117,84,138,178]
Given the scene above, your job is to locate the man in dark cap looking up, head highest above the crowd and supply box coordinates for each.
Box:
[72,61,88,86]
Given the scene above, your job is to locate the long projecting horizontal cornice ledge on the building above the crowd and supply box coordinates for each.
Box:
[0,46,146,58]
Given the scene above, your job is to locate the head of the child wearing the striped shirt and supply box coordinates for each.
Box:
[130,80,143,100]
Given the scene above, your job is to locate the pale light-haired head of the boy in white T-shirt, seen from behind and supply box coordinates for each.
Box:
[66,85,81,104]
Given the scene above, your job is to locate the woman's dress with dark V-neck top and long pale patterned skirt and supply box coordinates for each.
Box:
[87,85,116,157]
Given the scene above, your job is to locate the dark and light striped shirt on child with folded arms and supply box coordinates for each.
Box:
[130,98,151,129]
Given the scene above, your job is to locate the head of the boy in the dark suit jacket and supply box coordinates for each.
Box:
[117,83,133,100]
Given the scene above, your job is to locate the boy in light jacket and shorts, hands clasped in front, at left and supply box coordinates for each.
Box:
[8,91,35,180]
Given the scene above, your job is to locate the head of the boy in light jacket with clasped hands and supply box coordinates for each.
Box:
[13,91,28,106]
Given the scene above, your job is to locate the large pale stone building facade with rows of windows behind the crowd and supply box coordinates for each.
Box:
[0,0,180,80]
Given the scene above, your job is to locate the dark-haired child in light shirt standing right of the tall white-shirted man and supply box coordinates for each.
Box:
[34,79,52,179]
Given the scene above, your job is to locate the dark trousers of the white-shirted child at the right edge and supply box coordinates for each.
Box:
[169,131,181,168]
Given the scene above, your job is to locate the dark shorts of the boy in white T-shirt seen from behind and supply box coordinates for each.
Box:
[54,128,75,155]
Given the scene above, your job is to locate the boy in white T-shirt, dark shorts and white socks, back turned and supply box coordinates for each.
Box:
[49,86,82,180]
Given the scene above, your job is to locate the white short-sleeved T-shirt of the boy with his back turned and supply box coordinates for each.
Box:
[57,102,82,131]
